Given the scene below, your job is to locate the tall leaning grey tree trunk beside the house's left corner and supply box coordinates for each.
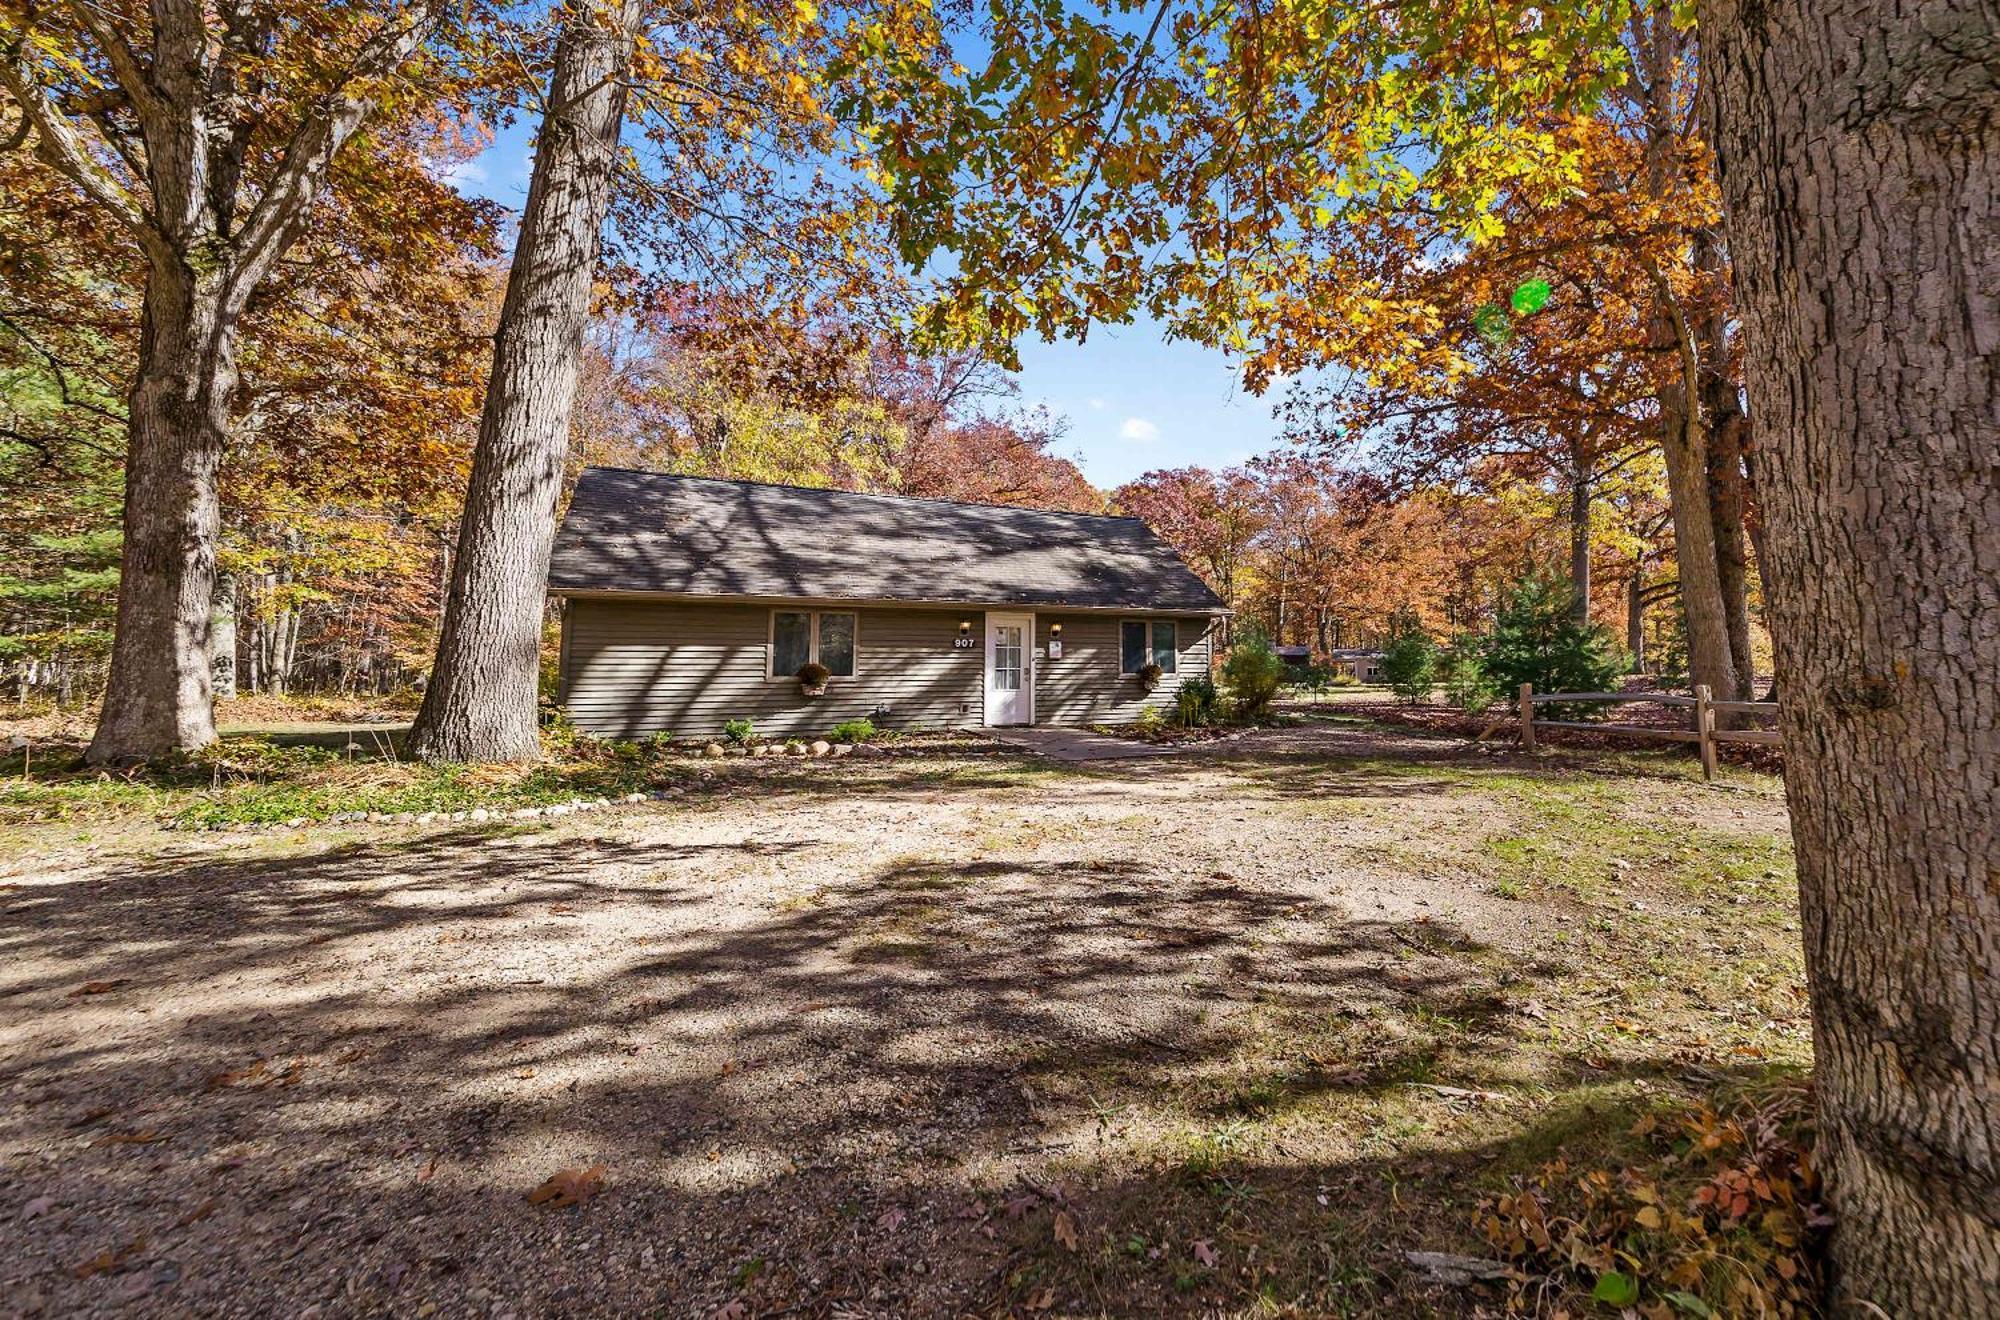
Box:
[410,0,638,760]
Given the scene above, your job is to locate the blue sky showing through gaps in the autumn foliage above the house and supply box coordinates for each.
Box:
[456,122,1282,490]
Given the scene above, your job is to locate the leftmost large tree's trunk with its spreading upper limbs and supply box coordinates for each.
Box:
[0,0,444,762]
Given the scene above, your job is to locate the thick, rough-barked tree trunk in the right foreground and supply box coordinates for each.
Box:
[1700,0,2000,1318]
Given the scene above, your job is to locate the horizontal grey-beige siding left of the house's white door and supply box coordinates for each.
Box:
[562,598,984,738]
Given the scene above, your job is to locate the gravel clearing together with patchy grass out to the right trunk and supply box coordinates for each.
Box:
[0,720,1808,1318]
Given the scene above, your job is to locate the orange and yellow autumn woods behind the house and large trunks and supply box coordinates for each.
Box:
[0,8,1766,706]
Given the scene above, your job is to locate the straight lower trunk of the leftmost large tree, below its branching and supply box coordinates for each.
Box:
[86,262,236,764]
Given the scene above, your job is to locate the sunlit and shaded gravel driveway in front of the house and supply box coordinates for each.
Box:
[0,730,1784,1316]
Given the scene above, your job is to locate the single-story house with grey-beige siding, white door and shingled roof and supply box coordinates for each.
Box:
[548,468,1228,738]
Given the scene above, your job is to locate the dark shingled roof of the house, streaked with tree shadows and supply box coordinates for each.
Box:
[548,468,1224,614]
